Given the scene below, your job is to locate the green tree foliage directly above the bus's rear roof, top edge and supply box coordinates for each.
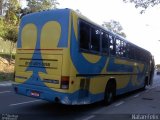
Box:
[27,0,59,12]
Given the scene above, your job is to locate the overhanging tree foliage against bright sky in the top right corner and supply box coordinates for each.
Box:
[123,0,160,14]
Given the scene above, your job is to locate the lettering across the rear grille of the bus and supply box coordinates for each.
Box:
[25,61,50,67]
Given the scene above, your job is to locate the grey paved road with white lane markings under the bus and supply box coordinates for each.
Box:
[0,75,160,120]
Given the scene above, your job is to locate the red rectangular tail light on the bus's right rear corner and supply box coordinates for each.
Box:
[61,76,69,89]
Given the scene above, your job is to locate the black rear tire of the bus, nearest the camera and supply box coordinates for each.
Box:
[104,81,116,106]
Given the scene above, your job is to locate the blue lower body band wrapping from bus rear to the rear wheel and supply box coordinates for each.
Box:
[13,84,104,105]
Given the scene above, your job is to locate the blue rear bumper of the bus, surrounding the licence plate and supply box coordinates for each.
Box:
[13,84,93,105]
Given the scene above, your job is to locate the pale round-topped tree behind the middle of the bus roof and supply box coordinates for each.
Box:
[102,20,126,37]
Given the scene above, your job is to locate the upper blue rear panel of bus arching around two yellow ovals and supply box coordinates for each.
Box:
[17,9,70,49]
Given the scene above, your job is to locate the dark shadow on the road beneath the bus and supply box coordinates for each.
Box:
[5,89,146,120]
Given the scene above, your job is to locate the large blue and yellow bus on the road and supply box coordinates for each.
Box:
[13,9,153,105]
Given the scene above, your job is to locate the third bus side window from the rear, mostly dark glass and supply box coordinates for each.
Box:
[101,32,109,54]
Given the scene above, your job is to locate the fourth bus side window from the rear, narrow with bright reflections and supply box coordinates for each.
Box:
[109,35,116,55]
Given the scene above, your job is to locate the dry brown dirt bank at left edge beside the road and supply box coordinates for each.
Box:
[0,57,14,81]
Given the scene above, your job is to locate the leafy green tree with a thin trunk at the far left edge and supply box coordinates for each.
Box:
[0,0,20,60]
